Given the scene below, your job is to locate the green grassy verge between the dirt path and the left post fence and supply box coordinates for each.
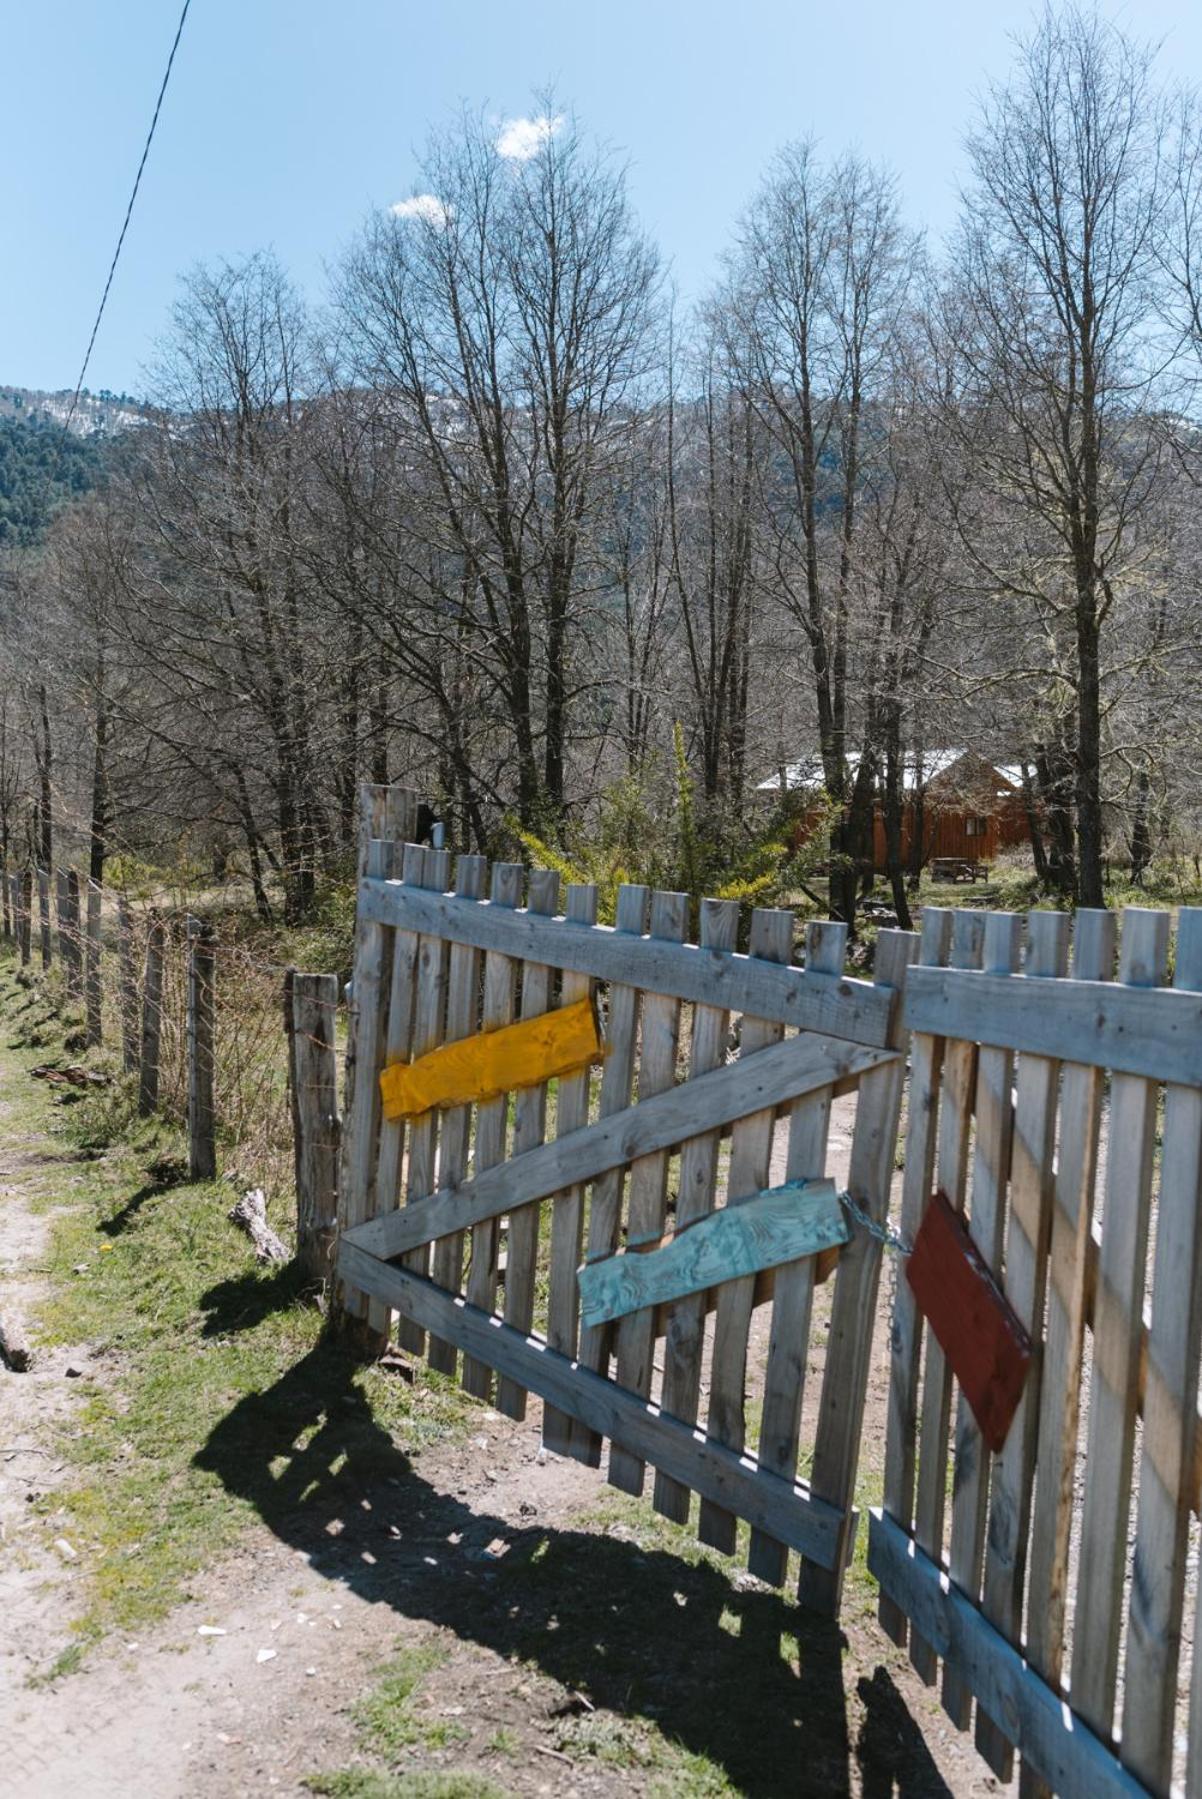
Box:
[0,964,471,1675]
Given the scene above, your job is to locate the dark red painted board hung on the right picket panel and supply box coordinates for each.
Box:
[905,1193,1031,1455]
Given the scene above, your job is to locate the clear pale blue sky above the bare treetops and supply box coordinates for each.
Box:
[9,0,1202,392]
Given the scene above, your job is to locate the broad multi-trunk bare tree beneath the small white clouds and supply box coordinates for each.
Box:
[340,101,657,826]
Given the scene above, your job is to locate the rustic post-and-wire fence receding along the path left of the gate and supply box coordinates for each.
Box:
[0,849,356,1283]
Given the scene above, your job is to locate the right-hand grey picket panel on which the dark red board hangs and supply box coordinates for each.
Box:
[869,908,1202,1799]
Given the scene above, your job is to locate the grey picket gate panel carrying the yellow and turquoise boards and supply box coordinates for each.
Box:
[338,798,918,1610]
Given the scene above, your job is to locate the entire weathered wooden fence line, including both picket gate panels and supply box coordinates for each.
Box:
[0,788,1202,1799]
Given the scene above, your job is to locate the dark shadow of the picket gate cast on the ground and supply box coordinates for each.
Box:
[196,1338,950,1799]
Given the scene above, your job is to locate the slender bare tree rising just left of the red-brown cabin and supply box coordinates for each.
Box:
[720,142,918,923]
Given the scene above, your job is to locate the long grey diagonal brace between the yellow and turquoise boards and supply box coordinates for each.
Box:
[342,1034,898,1284]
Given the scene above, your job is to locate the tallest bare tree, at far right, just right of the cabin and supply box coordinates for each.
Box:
[948,5,1164,907]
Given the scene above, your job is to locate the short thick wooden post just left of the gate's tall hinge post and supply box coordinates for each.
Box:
[284,970,342,1281]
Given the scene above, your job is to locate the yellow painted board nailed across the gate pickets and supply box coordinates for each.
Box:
[380,998,601,1119]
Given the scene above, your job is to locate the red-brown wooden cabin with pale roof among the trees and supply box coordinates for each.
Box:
[756,748,1027,874]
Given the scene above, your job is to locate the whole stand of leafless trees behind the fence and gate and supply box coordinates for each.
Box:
[0,7,1202,921]
